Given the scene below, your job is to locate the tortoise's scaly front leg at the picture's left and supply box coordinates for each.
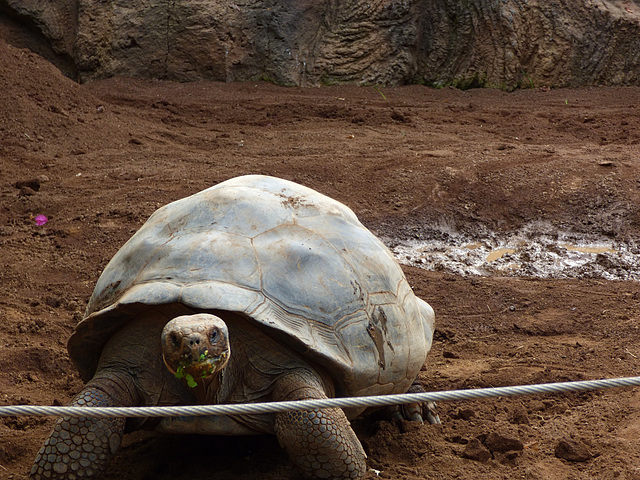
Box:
[30,374,136,480]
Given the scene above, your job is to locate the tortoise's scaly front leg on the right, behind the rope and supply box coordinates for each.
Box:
[274,370,367,479]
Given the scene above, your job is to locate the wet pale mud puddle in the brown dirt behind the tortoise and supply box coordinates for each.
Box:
[392,228,640,280]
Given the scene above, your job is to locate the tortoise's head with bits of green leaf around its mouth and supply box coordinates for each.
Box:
[161,313,231,387]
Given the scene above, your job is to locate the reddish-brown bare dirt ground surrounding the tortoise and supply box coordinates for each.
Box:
[0,37,640,480]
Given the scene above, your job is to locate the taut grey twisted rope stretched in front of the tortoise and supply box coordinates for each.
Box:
[0,377,640,418]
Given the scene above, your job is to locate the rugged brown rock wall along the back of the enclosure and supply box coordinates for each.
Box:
[0,0,640,89]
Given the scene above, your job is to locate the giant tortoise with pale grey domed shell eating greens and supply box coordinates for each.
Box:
[31,175,439,479]
